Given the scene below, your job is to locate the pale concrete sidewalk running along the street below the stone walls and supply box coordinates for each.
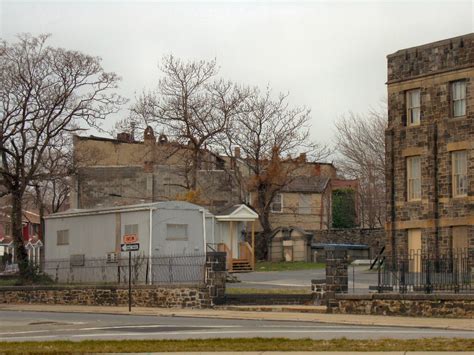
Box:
[0,304,474,331]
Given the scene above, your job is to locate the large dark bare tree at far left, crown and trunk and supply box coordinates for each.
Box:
[0,35,123,277]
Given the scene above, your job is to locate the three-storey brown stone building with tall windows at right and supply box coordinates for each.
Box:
[386,34,474,255]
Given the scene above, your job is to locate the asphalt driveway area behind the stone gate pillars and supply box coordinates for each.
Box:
[227,265,377,293]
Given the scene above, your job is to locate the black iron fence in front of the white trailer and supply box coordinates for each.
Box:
[41,254,206,285]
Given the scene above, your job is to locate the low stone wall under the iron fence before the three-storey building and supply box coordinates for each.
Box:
[328,294,474,318]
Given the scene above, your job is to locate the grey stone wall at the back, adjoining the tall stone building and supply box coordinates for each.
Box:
[313,228,385,258]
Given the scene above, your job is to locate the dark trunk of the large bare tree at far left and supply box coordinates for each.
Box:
[11,190,28,278]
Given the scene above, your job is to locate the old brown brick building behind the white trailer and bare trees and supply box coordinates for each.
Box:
[70,130,340,231]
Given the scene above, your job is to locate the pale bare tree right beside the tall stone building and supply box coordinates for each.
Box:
[335,110,387,228]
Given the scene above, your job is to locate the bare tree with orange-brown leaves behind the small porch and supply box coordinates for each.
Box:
[227,88,329,257]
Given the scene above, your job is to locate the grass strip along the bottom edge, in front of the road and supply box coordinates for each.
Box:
[0,338,474,354]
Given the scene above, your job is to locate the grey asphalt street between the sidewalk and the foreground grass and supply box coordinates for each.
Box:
[0,310,474,341]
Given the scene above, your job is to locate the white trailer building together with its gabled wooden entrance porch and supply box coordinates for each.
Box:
[44,201,258,281]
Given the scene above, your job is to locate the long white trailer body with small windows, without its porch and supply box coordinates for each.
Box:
[45,201,213,260]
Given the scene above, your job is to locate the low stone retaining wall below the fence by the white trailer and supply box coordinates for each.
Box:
[0,286,212,308]
